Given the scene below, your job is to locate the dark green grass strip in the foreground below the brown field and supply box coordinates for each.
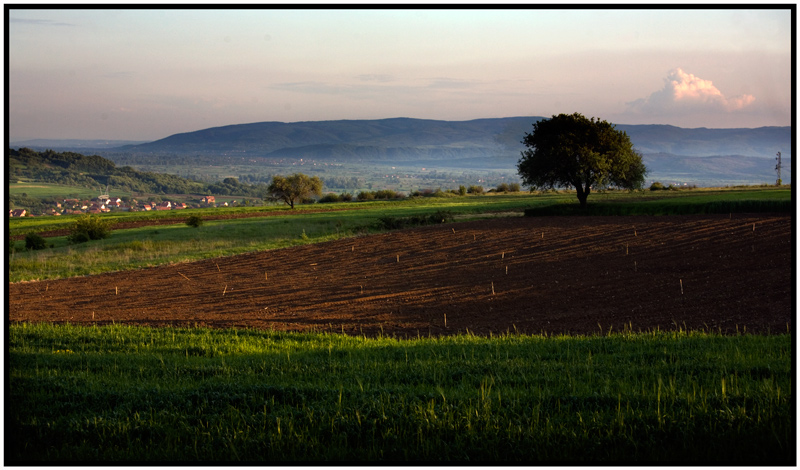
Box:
[5,323,796,465]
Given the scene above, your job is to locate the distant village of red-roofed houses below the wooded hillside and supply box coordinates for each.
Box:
[8,195,223,217]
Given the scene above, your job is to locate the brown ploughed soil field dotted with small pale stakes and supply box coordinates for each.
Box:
[8,214,794,337]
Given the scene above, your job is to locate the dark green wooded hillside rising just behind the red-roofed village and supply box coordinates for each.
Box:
[8,148,266,197]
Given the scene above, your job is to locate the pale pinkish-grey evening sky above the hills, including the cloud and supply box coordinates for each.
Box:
[6,5,795,142]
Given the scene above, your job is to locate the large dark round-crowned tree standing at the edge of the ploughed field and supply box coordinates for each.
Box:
[517,113,647,207]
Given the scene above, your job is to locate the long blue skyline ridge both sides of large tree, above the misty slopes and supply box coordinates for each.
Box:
[114,116,792,162]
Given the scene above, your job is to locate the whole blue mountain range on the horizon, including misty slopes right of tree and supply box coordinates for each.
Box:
[9,116,793,184]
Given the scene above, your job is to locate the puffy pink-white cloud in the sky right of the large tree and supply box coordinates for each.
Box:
[626,68,756,114]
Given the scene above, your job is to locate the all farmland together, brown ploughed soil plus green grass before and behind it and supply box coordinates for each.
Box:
[7,190,795,464]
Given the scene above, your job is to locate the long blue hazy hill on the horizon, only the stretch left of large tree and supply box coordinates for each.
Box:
[115,118,539,162]
